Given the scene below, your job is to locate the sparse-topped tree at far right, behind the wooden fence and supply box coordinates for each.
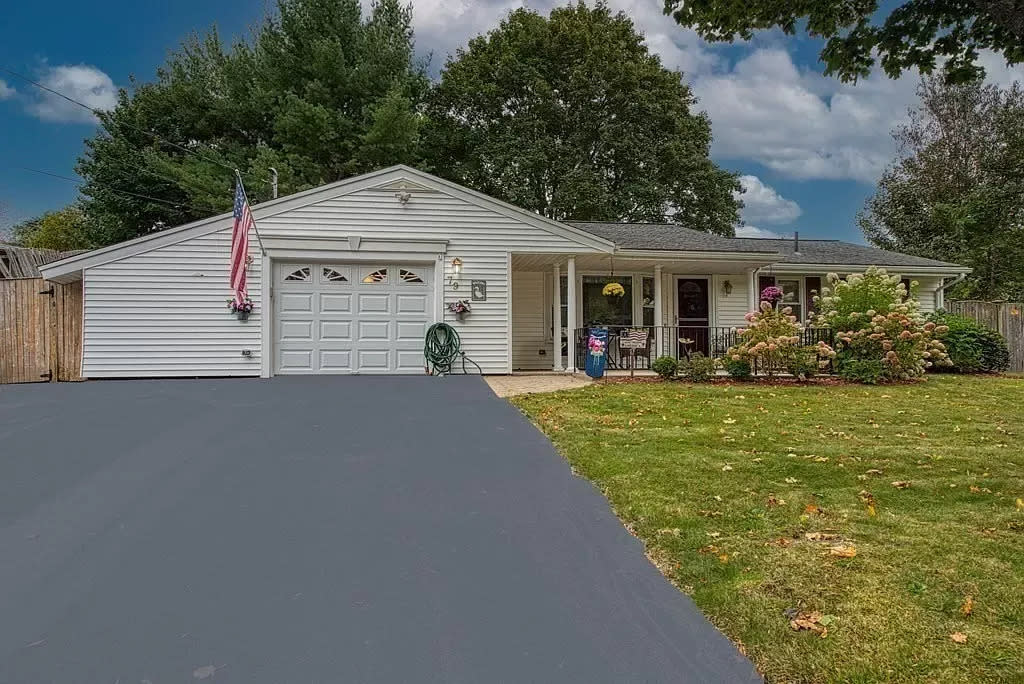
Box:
[858,77,1024,299]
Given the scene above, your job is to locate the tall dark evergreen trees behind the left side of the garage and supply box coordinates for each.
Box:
[77,0,429,244]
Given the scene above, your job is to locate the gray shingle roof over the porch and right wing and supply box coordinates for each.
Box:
[569,221,956,267]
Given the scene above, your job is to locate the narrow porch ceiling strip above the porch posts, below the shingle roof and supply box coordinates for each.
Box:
[512,253,774,274]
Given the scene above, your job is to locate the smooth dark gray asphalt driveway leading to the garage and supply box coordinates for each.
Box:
[0,377,757,684]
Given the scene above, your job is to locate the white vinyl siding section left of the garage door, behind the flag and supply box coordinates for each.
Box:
[82,228,263,378]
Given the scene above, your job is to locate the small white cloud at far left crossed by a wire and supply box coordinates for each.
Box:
[28,65,118,123]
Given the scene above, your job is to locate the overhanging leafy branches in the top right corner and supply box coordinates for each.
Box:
[665,0,1024,82]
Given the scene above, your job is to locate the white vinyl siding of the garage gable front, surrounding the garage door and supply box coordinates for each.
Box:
[83,180,594,378]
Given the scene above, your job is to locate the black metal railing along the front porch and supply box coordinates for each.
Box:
[575,326,834,370]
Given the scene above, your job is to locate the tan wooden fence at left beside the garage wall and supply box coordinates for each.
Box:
[0,277,82,383]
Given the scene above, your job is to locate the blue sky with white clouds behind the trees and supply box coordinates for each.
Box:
[0,0,1019,242]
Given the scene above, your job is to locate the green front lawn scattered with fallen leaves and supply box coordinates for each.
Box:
[514,376,1024,683]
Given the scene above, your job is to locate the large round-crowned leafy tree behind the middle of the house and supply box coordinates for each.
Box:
[424,2,739,234]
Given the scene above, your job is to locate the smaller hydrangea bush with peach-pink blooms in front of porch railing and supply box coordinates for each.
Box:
[726,301,835,379]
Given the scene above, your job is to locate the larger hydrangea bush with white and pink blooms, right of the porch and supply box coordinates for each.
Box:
[814,267,949,382]
